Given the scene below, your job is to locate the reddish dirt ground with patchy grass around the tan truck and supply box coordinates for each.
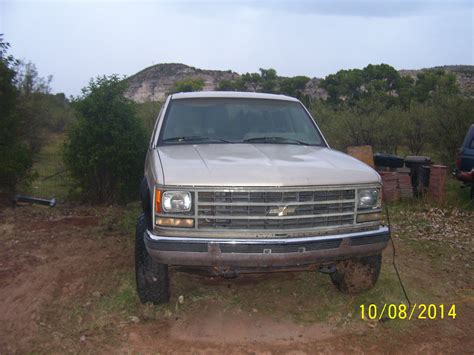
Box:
[0,202,474,354]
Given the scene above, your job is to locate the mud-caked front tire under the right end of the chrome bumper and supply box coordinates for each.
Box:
[330,254,382,294]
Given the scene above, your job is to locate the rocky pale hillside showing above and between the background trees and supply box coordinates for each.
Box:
[126,63,474,102]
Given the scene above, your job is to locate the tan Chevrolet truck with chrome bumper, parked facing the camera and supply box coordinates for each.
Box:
[135,92,389,304]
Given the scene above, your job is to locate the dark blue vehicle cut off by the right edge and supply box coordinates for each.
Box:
[454,124,474,199]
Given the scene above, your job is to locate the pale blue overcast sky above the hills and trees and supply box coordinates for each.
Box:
[0,0,474,95]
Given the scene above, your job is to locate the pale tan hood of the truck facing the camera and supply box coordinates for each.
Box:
[158,144,380,186]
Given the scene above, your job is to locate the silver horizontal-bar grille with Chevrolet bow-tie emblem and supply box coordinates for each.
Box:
[196,189,355,230]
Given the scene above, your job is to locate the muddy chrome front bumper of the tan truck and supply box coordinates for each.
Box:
[145,226,389,269]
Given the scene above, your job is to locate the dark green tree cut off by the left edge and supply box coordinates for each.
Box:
[0,35,32,193]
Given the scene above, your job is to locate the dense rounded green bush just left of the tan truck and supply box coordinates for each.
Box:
[64,75,147,202]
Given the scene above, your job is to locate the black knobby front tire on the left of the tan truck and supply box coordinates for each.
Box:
[135,213,170,304]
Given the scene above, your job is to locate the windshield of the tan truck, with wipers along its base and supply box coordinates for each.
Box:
[158,98,325,146]
